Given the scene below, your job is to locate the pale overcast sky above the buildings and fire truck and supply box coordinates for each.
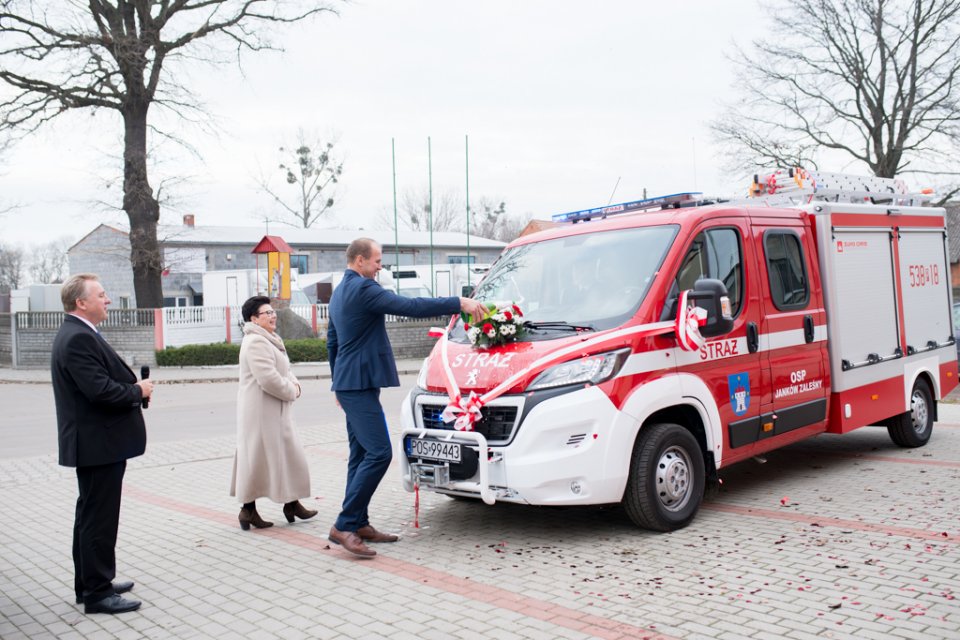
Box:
[0,0,767,244]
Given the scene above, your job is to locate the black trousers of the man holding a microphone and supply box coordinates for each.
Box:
[73,460,127,604]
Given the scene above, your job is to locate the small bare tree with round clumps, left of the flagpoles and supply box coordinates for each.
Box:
[260,130,343,229]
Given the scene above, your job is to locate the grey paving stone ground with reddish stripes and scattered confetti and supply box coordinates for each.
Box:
[0,405,960,640]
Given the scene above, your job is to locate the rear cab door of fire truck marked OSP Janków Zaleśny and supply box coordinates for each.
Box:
[753,224,830,453]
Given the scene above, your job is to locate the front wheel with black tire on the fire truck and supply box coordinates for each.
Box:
[623,423,706,531]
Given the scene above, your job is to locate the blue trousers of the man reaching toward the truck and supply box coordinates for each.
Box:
[333,389,393,531]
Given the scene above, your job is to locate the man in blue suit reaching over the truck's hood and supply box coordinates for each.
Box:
[327,238,486,557]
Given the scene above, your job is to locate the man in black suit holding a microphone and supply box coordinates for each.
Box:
[50,273,153,613]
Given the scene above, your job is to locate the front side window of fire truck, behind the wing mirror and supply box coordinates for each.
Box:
[661,228,743,320]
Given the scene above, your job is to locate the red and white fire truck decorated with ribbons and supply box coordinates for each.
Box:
[398,169,957,531]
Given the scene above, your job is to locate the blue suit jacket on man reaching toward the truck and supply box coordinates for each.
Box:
[327,269,460,391]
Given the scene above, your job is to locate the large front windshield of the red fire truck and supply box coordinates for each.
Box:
[474,225,678,330]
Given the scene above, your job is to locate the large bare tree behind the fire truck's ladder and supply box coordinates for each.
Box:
[712,0,960,200]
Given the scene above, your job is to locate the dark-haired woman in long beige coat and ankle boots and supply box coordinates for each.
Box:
[230,296,317,531]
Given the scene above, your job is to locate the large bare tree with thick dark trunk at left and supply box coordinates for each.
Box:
[0,0,333,307]
